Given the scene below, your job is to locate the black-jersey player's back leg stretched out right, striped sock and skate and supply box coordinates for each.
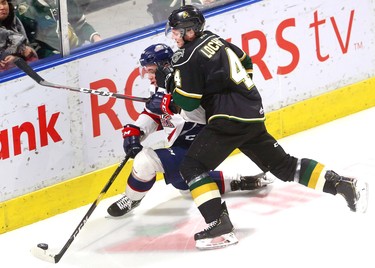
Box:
[240,124,368,212]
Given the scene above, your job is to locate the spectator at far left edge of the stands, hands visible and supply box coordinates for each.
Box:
[0,0,37,72]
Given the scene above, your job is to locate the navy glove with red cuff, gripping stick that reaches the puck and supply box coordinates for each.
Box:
[122,124,143,158]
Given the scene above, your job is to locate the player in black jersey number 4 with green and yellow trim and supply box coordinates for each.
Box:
[145,5,367,249]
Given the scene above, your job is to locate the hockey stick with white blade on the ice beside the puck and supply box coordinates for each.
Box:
[31,156,130,263]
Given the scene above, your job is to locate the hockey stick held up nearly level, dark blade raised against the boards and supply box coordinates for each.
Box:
[14,58,150,102]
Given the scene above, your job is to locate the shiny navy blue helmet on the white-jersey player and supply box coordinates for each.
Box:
[139,44,173,68]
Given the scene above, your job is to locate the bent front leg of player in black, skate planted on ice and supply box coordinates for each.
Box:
[180,119,260,248]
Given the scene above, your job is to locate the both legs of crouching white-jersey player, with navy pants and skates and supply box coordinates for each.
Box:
[107,142,267,217]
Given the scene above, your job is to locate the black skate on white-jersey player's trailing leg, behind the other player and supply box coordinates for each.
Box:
[230,173,274,191]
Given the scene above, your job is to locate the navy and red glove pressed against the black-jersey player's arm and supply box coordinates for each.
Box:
[146,92,177,115]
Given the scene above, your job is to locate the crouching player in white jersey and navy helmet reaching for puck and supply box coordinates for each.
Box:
[107,44,272,217]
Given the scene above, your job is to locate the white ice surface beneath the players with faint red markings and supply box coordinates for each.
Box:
[0,108,375,268]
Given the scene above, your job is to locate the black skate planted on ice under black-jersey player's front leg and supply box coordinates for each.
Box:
[194,202,238,249]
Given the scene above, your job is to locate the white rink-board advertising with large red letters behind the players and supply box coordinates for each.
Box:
[0,0,375,202]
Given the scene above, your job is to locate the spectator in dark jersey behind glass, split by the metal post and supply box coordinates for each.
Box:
[17,0,101,58]
